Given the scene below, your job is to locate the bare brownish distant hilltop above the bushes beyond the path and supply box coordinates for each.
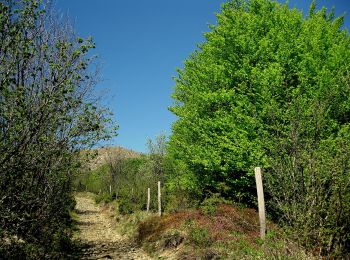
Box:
[82,146,142,170]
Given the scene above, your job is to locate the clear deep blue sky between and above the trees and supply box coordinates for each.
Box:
[56,0,350,152]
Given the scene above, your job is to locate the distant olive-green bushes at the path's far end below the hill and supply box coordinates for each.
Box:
[79,155,157,211]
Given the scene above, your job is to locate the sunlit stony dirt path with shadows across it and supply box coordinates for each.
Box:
[75,193,151,259]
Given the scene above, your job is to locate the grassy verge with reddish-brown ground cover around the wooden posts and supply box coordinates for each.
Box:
[95,195,312,260]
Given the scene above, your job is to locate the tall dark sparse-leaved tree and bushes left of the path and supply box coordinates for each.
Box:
[0,0,112,259]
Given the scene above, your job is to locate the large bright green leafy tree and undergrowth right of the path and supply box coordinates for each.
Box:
[169,0,350,254]
